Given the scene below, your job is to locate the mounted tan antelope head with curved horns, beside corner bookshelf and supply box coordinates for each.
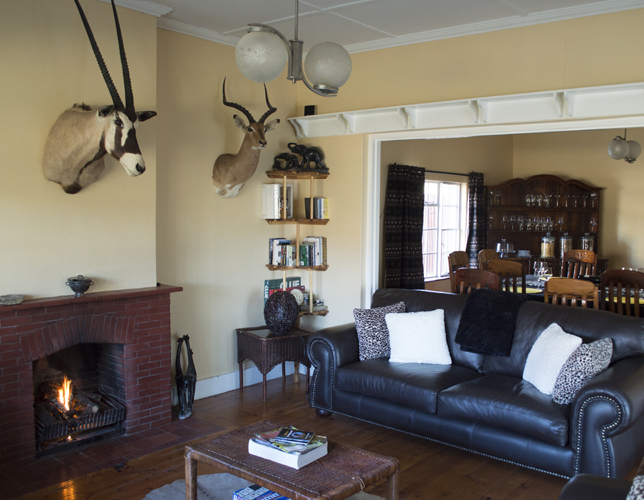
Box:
[212,78,280,198]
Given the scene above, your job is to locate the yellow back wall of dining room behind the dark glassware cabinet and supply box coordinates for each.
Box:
[514,129,644,269]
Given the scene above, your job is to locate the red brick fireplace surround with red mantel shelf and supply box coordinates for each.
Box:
[0,285,182,468]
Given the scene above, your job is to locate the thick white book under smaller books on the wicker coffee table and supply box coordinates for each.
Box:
[248,428,328,469]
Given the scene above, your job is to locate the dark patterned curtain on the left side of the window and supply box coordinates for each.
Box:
[384,164,425,289]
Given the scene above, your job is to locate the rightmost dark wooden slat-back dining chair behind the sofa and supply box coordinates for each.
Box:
[601,269,644,318]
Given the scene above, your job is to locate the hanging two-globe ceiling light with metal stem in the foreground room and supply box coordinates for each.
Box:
[235,0,351,97]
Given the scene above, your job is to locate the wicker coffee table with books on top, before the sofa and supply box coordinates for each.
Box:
[185,421,400,500]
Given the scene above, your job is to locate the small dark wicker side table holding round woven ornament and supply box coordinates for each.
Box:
[236,326,311,402]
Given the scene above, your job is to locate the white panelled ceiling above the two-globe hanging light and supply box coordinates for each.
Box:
[102,0,644,53]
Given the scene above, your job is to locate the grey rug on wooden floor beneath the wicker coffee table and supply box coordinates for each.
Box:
[143,472,383,500]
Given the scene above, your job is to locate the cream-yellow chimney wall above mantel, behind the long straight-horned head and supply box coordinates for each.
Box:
[0,0,157,298]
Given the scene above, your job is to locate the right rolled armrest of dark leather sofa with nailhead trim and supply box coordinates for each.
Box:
[570,355,644,477]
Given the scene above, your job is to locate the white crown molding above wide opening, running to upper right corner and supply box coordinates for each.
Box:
[344,0,644,54]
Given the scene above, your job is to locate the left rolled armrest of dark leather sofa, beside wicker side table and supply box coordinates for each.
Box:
[306,323,359,411]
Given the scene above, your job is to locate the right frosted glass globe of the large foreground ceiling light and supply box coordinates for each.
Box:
[304,42,351,89]
